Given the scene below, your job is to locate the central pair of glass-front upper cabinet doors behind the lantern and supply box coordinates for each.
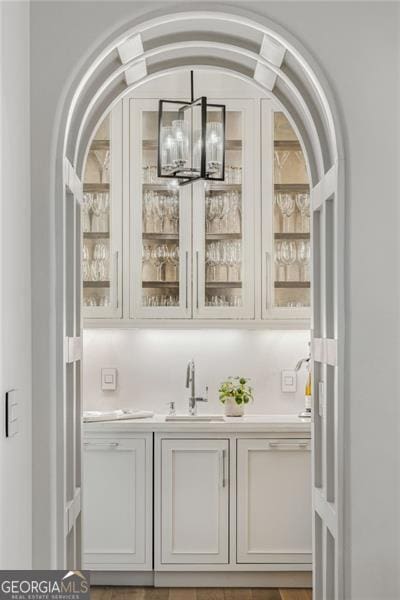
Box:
[130,100,254,319]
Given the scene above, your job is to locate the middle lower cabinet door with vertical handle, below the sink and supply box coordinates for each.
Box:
[161,439,229,565]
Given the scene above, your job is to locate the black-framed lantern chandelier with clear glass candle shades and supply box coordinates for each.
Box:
[157,71,225,185]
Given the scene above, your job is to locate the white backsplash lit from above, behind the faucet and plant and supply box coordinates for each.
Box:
[83,329,309,414]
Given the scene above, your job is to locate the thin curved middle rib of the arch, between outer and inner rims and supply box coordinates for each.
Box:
[74,40,324,177]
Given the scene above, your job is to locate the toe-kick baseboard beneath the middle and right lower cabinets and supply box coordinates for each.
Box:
[154,571,312,588]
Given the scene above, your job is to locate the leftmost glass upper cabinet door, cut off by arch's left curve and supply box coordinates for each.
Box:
[81,106,122,318]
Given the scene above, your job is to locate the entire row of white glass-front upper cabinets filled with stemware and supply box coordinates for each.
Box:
[82,98,311,326]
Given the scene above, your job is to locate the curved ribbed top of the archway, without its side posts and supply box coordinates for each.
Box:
[64,8,338,181]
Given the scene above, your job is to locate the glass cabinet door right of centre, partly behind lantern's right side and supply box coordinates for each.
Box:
[193,100,257,319]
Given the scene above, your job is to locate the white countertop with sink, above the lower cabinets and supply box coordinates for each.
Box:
[84,415,311,433]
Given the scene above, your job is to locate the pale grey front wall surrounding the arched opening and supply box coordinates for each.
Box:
[31,0,400,600]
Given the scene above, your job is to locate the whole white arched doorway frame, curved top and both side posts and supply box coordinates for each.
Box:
[49,11,344,598]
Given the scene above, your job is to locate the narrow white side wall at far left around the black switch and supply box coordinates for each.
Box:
[0,2,32,569]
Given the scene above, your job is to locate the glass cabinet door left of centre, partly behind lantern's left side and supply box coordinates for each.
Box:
[129,99,191,318]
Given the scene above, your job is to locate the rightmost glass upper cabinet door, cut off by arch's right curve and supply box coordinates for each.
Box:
[263,101,311,319]
